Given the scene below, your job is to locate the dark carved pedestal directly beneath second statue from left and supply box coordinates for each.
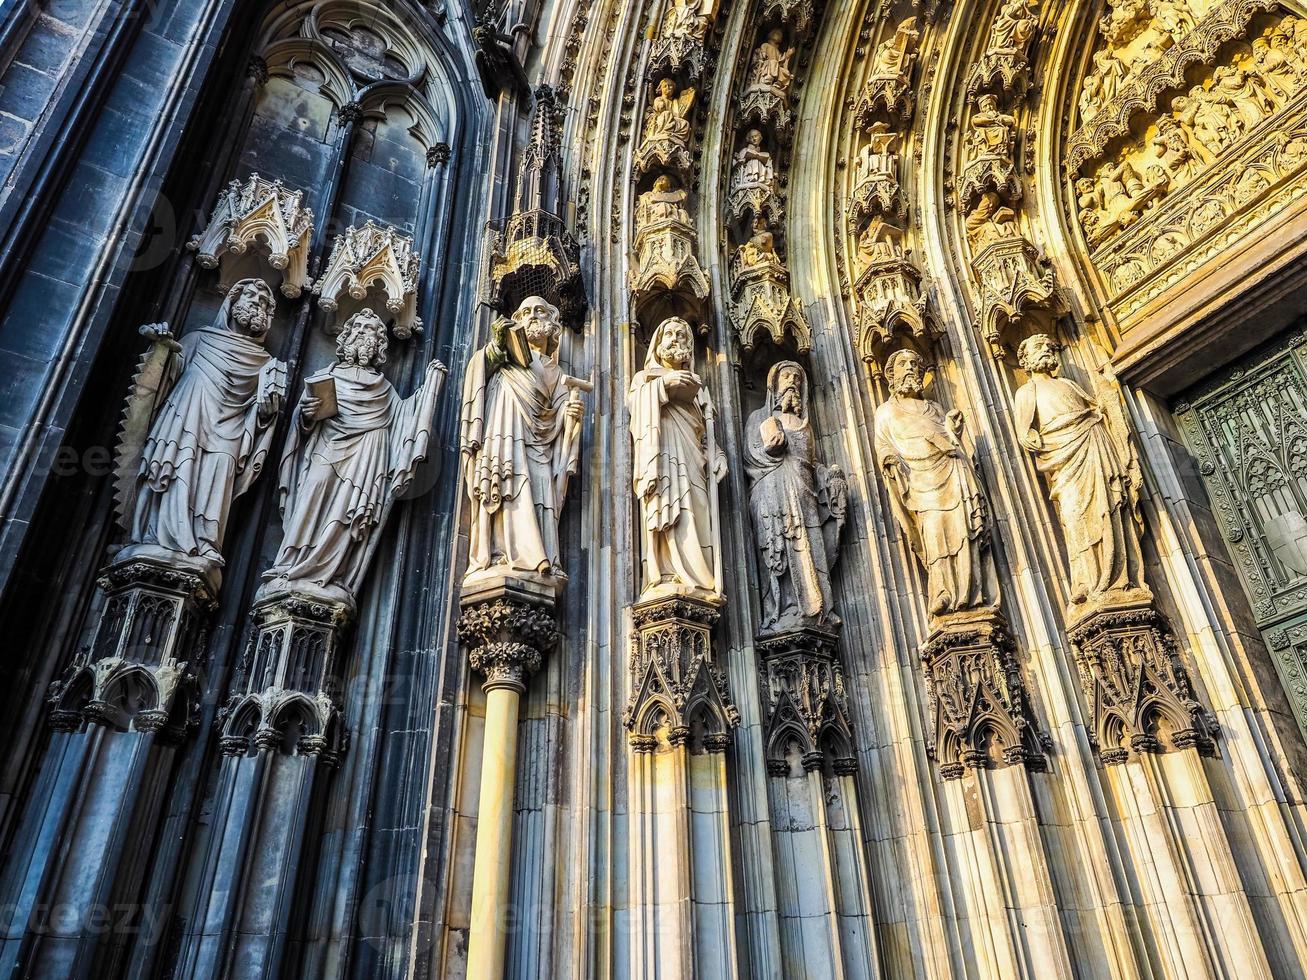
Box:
[218,593,350,767]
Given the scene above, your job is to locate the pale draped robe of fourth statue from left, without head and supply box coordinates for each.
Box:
[627,365,720,595]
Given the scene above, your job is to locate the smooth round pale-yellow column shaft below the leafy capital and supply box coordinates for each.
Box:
[468,685,521,980]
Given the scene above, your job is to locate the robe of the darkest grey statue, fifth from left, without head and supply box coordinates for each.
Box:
[745,408,838,632]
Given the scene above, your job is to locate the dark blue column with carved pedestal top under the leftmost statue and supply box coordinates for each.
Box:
[0,559,213,976]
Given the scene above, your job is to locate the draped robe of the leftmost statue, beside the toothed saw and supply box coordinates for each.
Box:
[119,322,273,570]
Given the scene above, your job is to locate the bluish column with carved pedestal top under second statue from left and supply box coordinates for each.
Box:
[176,593,352,977]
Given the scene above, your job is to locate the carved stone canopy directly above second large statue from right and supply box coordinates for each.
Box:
[853,257,938,378]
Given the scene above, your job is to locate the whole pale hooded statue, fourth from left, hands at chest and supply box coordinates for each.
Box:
[626,316,727,600]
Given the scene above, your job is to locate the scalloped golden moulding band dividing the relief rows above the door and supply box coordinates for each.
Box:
[1065,0,1280,172]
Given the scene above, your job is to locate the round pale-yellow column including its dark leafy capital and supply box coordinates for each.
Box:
[459,578,558,980]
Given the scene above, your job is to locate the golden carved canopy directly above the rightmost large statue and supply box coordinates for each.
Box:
[971,238,1067,357]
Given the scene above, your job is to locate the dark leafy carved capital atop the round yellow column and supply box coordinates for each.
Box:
[459,595,558,694]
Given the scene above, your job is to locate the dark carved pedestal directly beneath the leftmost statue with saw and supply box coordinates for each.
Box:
[50,561,213,742]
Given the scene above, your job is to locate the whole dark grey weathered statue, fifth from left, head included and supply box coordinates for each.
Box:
[745,361,848,635]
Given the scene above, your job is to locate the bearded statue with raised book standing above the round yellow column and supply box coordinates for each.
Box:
[460,297,588,588]
